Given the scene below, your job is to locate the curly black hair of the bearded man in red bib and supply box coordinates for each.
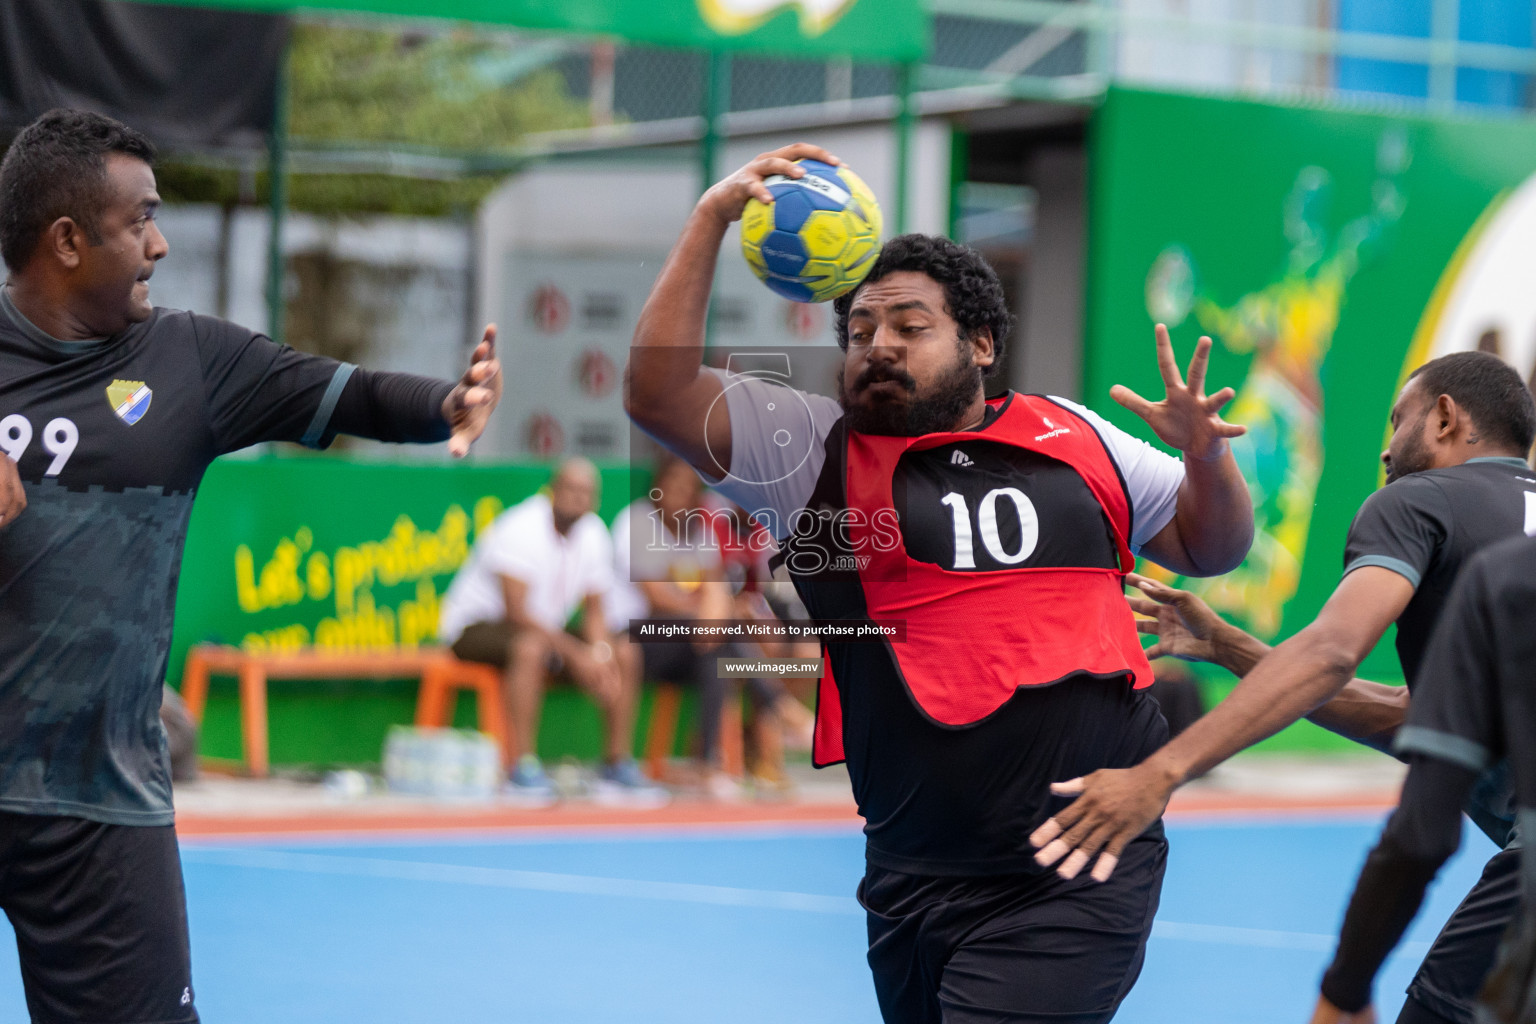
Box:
[833,235,1014,376]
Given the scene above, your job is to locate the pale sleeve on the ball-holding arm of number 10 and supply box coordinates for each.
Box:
[699,370,843,539]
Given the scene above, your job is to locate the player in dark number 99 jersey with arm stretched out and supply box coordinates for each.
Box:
[0,111,501,1024]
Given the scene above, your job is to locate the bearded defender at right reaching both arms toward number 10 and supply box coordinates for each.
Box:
[1037,352,1536,1024]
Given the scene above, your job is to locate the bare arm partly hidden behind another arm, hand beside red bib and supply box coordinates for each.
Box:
[1126,573,1409,754]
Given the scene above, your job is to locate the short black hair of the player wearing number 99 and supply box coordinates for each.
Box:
[0,107,155,272]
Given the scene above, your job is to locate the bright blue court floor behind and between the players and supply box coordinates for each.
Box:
[0,817,1493,1024]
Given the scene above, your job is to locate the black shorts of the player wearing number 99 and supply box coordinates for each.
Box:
[0,812,198,1024]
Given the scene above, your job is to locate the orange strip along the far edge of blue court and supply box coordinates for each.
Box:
[177,791,1398,841]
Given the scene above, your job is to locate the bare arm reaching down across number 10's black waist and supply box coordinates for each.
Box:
[1029,565,1413,881]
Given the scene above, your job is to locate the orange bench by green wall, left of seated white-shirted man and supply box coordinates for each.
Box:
[181,643,516,778]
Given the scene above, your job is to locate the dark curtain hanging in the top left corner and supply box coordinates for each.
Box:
[0,0,289,147]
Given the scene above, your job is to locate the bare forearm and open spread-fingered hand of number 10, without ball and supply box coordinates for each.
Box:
[1109,324,1253,576]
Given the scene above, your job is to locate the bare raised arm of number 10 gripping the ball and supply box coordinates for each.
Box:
[624,143,842,476]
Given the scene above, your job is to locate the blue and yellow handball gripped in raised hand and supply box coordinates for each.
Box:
[742,160,880,302]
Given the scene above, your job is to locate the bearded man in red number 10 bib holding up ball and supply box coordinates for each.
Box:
[625,144,1253,1024]
